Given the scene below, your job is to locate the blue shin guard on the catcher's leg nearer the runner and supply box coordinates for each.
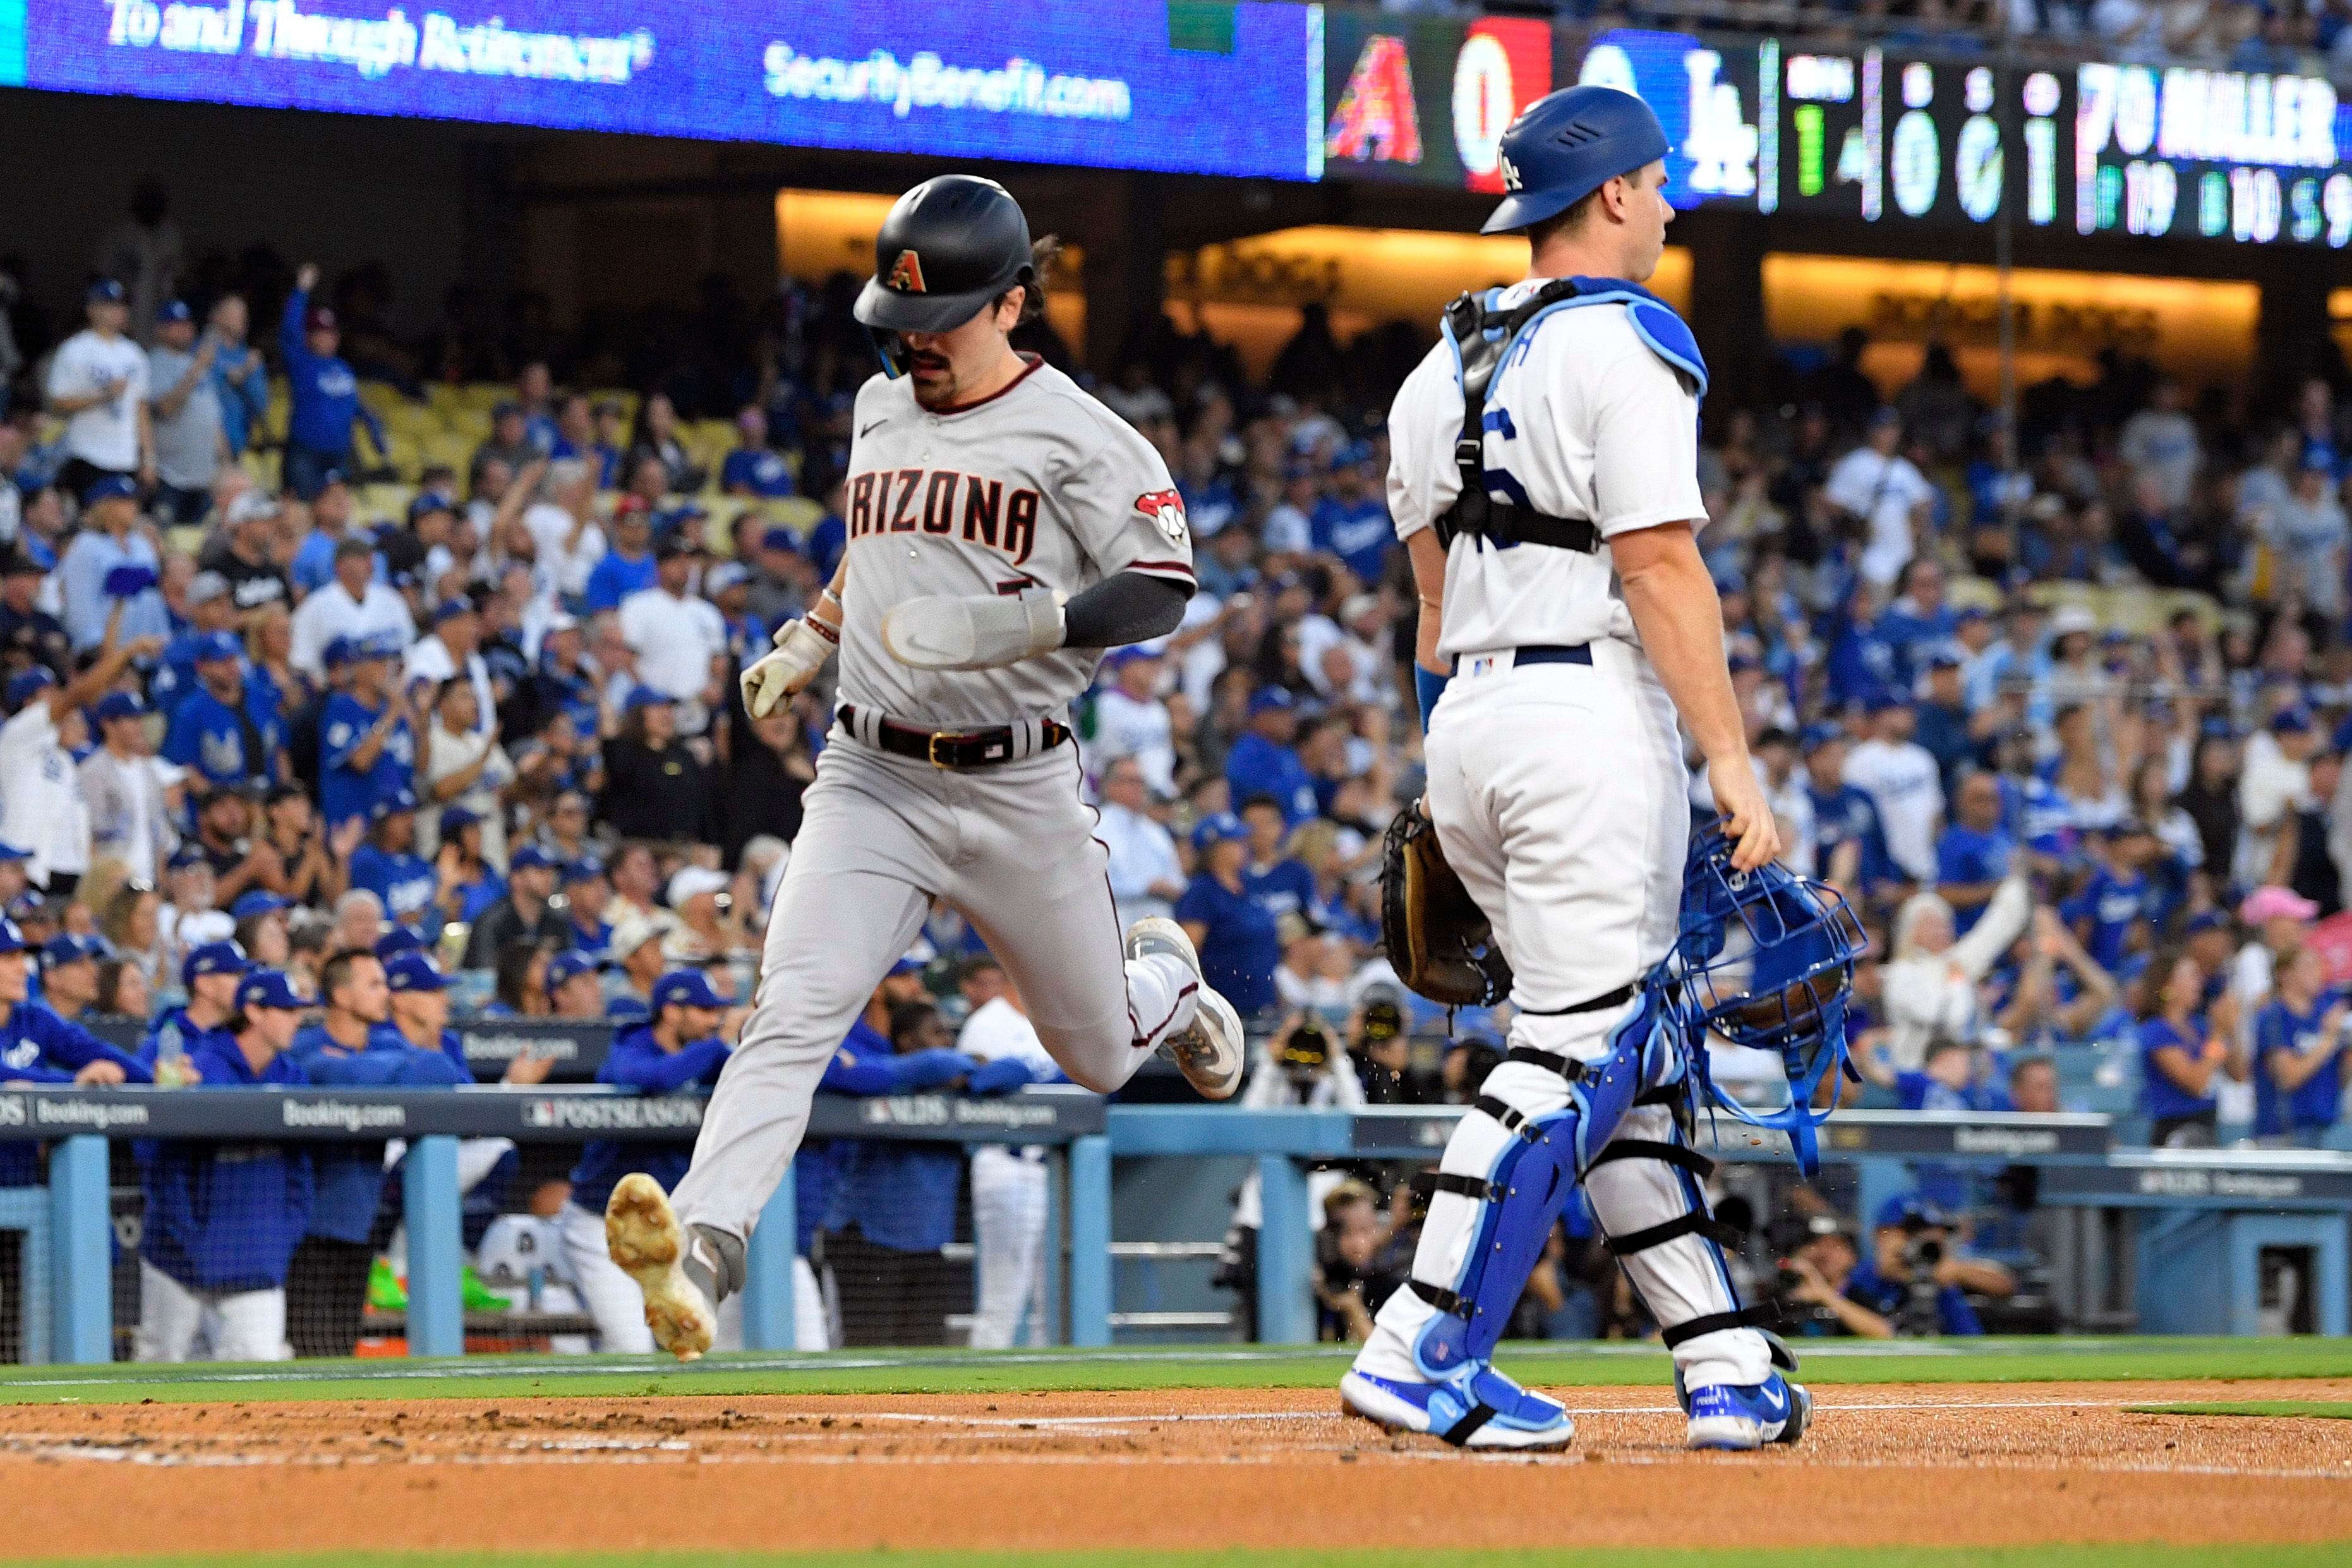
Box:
[1409,990,1679,1382]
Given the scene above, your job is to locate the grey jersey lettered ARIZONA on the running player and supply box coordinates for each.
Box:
[840,359,1193,727]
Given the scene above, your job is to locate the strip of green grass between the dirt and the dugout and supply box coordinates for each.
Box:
[0,1337,2352,1404]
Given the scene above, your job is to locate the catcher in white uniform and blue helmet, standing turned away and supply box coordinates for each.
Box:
[1341,87,1804,1448]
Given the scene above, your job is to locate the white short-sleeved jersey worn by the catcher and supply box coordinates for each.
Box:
[1388,277,1708,656]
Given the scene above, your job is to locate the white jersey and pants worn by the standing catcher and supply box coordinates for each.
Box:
[1357,280,1771,1387]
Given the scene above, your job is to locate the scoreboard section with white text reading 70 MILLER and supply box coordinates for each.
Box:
[2075,63,2352,249]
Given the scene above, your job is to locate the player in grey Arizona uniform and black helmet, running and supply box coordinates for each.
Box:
[605,174,1244,1359]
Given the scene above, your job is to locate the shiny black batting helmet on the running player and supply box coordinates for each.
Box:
[856,174,1037,334]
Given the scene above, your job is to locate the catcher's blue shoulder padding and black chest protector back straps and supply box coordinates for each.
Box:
[1435,277,1708,555]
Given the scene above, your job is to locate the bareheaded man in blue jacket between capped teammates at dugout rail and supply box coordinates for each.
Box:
[287,948,471,1356]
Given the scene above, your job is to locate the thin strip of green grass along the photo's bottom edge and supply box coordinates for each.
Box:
[23,1542,2352,1568]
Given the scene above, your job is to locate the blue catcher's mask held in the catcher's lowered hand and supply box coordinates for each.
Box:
[1663,823,1870,1176]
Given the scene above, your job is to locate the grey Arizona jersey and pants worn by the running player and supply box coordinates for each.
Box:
[670,359,1197,1236]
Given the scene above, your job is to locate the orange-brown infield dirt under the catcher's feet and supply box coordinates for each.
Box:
[0,1378,2352,1556]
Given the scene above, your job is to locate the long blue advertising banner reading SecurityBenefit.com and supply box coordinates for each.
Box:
[0,0,1322,179]
